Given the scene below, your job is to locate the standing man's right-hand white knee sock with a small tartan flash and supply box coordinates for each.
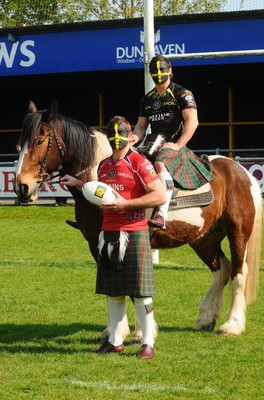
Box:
[134,297,154,347]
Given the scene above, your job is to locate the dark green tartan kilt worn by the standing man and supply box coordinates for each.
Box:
[96,229,156,297]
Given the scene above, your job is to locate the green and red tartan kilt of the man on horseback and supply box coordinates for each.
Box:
[156,146,213,190]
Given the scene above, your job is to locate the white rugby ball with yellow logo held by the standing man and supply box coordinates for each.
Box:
[82,181,116,206]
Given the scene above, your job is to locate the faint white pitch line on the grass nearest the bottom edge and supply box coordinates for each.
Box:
[66,379,214,393]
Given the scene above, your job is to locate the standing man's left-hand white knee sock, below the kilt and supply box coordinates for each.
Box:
[107,296,126,346]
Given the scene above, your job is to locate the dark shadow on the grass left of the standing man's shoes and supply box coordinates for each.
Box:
[0,323,106,354]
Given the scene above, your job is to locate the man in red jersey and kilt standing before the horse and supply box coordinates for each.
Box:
[61,116,166,359]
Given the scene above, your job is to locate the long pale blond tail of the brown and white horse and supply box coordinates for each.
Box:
[245,176,263,304]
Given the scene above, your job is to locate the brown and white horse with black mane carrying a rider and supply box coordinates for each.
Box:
[14,101,263,335]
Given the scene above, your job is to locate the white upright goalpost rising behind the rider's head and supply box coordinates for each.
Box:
[144,0,155,93]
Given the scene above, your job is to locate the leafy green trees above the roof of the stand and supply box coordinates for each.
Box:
[0,0,227,28]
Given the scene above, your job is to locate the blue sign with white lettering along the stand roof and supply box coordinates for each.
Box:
[0,19,264,76]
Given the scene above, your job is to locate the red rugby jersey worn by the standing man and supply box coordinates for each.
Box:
[98,150,159,231]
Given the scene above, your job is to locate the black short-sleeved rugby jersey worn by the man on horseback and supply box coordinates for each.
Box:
[139,82,197,142]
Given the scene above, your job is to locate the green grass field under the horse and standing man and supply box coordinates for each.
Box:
[0,206,264,400]
